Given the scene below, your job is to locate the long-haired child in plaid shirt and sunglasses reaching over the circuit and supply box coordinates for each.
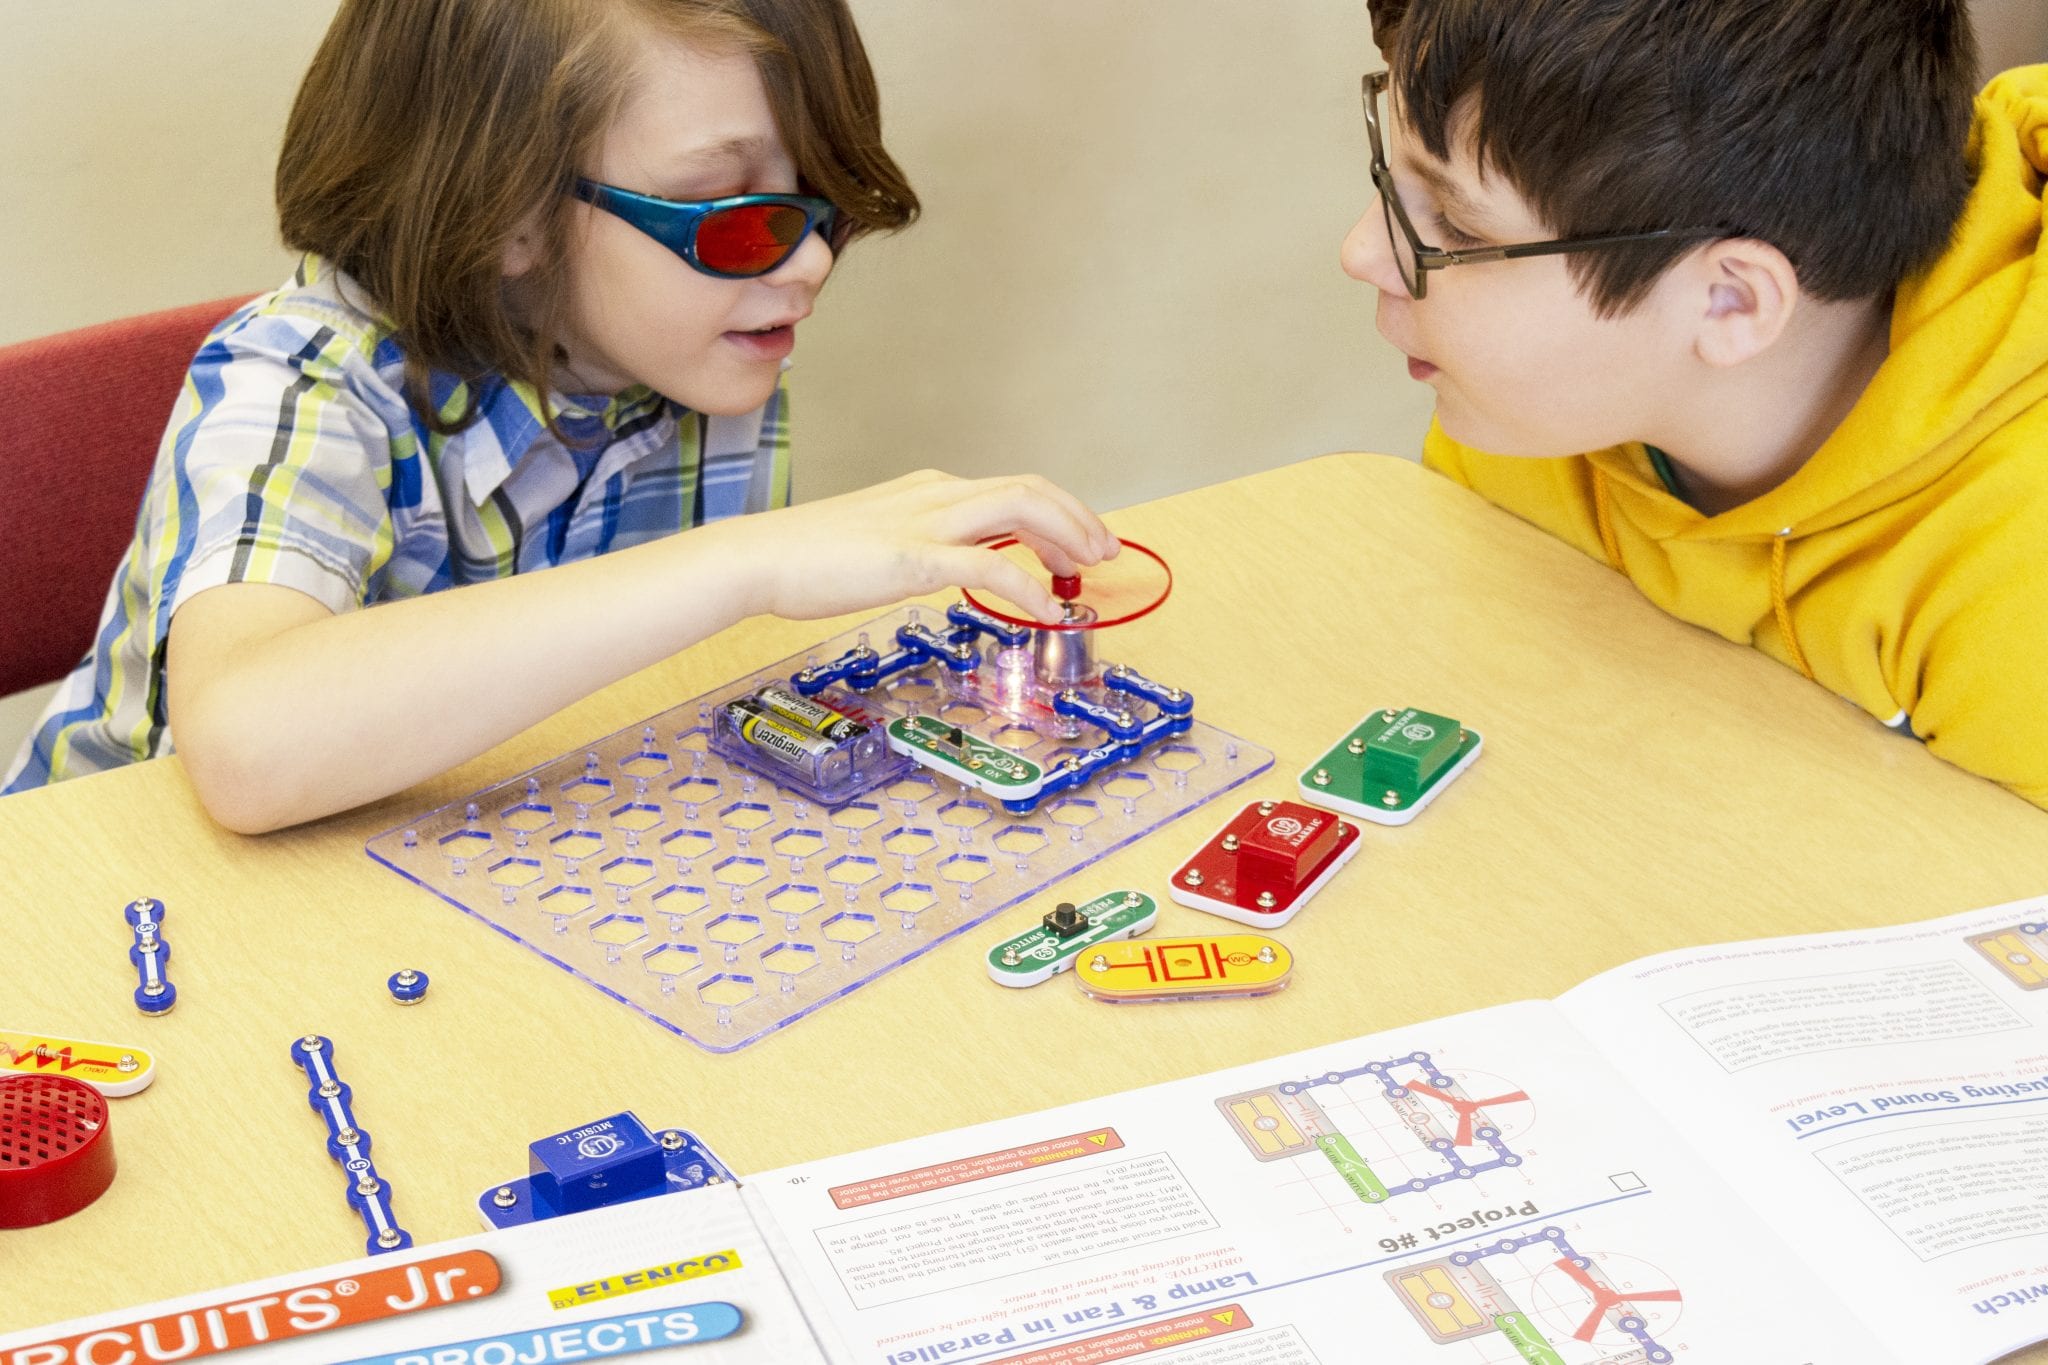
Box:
[6,0,1116,831]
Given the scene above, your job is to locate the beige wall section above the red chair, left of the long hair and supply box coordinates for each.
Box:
[0,0,334,342]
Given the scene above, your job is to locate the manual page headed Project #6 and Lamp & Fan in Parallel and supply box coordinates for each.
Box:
[748,1003,1884,1365]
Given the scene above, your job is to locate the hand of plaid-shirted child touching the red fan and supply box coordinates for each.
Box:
[729,469,1118,620]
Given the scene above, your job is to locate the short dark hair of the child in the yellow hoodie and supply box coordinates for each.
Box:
[1368,0,1976,315]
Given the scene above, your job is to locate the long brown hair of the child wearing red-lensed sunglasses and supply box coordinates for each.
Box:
[276,0,918,432]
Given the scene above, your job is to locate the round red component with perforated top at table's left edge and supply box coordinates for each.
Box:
[0,1076,115,1228]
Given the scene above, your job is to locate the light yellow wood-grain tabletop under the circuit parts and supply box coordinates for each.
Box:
[12,456,2048,1361]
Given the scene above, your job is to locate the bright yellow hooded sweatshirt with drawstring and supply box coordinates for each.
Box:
[1423,65,2048,806]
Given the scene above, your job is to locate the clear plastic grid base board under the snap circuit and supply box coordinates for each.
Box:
[367,608,1274,1052]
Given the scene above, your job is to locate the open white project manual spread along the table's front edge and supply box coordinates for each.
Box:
[12,898,2048,1365]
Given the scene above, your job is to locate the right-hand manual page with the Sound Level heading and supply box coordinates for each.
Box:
[1559,898,2048,1361]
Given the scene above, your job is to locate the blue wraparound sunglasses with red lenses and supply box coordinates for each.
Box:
[575,180,840,280]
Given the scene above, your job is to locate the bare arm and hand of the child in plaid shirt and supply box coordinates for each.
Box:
[166,473,1114,833]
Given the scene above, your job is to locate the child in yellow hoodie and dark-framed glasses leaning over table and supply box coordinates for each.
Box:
[1343,0,2048,806]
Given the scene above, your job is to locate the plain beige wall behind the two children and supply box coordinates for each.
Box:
[0,0,1427,515]
